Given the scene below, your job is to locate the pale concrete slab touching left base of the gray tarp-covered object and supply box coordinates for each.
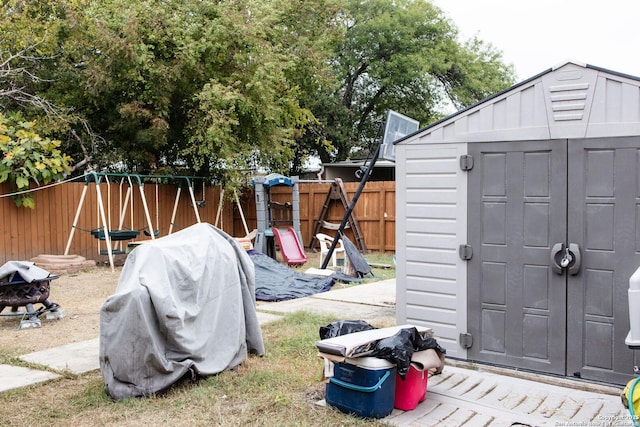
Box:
[20,338,100,374]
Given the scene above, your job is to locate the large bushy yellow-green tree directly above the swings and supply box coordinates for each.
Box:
[74,0,324,186]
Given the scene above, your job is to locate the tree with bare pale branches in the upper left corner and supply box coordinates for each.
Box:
[0,0,99,176]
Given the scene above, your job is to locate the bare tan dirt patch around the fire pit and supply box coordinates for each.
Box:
[0,267,122,356]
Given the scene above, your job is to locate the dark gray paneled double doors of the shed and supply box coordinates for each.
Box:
[467,138,640,384]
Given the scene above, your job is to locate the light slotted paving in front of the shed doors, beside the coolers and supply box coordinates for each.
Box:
[387,366,633,427]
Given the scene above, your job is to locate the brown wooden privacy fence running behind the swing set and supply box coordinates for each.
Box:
[0,181,395,265]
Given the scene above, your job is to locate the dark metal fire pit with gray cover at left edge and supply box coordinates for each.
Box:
[0,262,64,329]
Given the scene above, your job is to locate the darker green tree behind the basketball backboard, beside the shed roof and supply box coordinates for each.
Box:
[300,0,514,162]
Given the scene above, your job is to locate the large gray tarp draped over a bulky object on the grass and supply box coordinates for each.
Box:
[100,223,264,399]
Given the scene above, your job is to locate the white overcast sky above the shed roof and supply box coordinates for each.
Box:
[432,0,640,81]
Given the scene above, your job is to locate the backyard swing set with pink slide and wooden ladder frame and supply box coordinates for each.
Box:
[61,172,367,269]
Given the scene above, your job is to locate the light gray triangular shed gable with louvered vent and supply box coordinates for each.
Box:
[399,61,640,144]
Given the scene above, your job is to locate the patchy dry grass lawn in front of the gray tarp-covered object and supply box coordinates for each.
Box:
[0,313,386,426]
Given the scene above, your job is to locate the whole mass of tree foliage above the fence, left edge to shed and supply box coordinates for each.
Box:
[0,0,514,196]
